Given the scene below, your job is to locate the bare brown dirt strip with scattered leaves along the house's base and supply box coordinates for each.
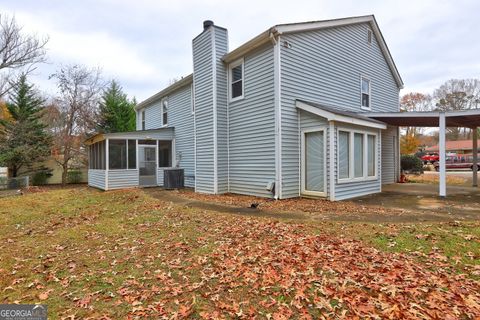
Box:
[145,188,480,223]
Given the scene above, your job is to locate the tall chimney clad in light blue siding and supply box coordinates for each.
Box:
[193,26,228,193]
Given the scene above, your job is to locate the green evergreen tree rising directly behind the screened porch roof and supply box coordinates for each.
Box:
[98,80,136,133]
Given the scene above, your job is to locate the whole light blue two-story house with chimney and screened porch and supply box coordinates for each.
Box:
[86,15,403,200]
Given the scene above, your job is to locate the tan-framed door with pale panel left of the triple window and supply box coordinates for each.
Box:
[301,130,326,196]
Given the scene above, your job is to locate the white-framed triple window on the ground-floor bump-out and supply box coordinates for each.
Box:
[337,130,378,182]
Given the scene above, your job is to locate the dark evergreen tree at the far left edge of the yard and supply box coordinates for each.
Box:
[0,75,52,177]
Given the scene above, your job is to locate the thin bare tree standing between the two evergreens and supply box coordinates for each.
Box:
[49,65,104,185]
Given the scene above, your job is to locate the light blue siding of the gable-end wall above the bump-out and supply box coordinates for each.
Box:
[280,24,399,198]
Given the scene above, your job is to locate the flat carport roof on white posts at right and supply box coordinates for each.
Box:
[363,109,480,128]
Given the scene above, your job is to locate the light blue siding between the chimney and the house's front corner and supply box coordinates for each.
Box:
[228,45,275,197]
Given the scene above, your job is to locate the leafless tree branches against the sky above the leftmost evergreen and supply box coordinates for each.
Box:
[0,14,48,98]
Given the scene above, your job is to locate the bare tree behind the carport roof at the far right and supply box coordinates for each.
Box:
[433,79,480,140]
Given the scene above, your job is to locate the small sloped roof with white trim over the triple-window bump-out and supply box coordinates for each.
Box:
[295,99,387,129]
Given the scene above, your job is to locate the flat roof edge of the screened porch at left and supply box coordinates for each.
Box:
[85,127,175,145]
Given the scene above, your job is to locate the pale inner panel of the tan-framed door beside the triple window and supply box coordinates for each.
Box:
[305,131,325,192]
